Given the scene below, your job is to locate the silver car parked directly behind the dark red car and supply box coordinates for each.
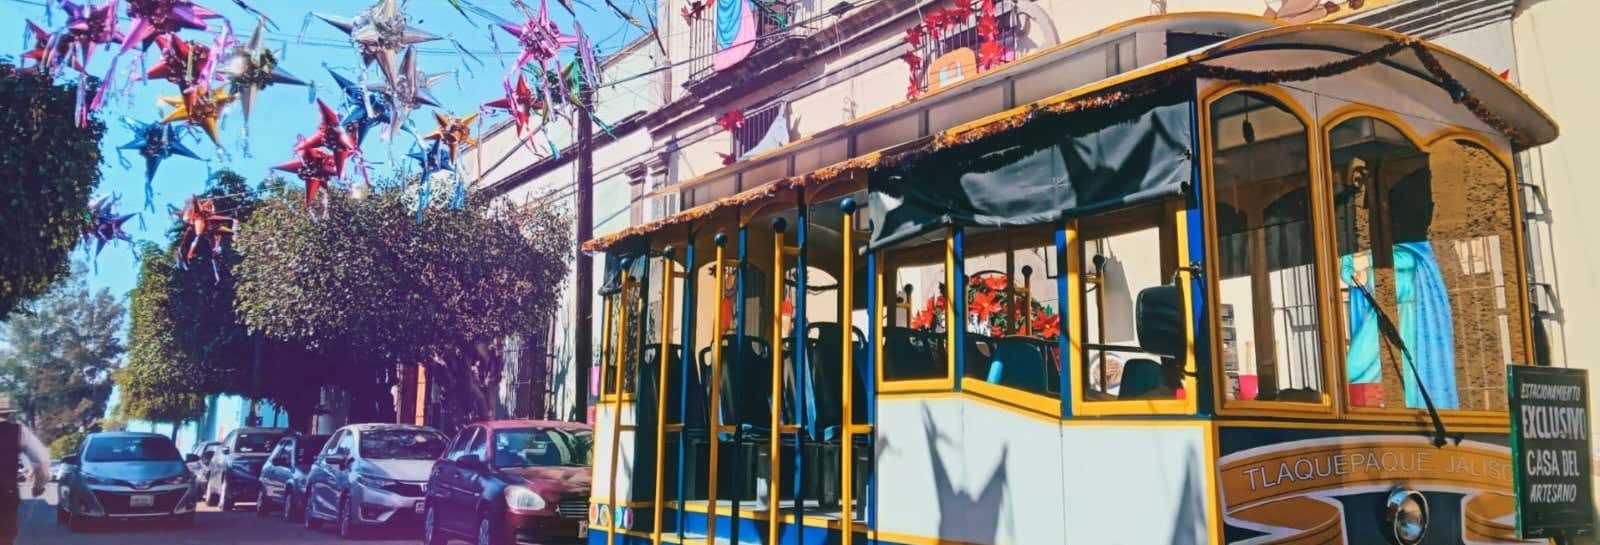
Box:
[306,424,446,539]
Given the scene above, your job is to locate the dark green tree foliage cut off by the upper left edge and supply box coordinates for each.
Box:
[0,64,106,318]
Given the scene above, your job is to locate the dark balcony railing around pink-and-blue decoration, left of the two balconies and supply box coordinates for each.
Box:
[688,0,830,82]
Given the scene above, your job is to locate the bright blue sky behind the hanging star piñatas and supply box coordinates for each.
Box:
[0,0,654,302]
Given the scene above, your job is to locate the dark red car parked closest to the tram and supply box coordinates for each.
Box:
[422,420,594,545]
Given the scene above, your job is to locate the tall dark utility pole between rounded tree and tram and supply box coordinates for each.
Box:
[573,83,595,422]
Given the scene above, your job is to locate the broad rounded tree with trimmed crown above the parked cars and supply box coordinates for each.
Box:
[237,183,571,428]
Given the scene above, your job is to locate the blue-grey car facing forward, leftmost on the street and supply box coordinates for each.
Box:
[56,432,200,532]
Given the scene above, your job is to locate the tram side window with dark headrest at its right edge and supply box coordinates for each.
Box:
[1077,201,1184,401]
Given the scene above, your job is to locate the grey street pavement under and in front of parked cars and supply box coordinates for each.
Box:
[16,484,421,545]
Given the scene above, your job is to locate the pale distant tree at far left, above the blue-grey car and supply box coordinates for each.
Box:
[0,267,126,441]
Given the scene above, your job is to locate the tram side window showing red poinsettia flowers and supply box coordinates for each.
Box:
[962,229,1061,398]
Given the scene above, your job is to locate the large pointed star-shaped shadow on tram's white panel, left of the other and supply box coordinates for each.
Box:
[922,406,1008,543]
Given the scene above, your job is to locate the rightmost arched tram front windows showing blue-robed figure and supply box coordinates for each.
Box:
[1328,117,1530,411]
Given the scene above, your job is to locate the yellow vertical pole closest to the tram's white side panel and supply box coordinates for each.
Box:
[838,198,856,545]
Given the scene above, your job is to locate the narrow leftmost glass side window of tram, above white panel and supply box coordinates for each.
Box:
[883,241,950,380]
